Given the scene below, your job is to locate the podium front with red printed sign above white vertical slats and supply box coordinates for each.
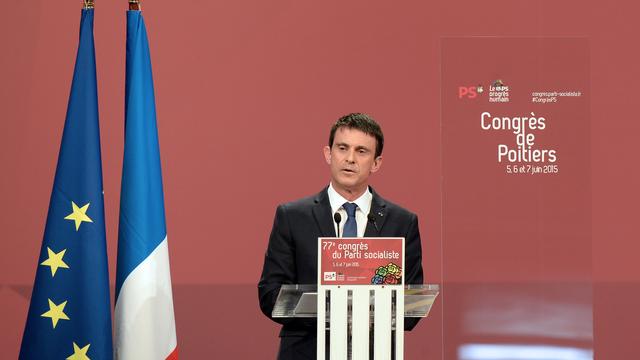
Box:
[316,238,404,360]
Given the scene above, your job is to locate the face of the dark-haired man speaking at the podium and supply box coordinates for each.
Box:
[324,127,382,197]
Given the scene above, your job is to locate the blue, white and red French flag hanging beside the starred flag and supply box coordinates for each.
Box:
[115,10,178,360]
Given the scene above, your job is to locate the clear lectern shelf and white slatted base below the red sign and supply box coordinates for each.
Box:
[272,285,440,360]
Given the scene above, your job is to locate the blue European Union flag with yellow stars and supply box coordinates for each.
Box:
[20,9,113,360]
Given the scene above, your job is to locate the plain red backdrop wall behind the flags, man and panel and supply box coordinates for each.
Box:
[0,0,640,359]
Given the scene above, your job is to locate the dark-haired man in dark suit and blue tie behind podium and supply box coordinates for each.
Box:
[258,113,423,360]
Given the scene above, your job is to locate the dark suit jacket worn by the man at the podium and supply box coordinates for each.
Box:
[258,188,423,359]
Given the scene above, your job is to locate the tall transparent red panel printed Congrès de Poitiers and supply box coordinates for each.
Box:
[440,37,593,360]
